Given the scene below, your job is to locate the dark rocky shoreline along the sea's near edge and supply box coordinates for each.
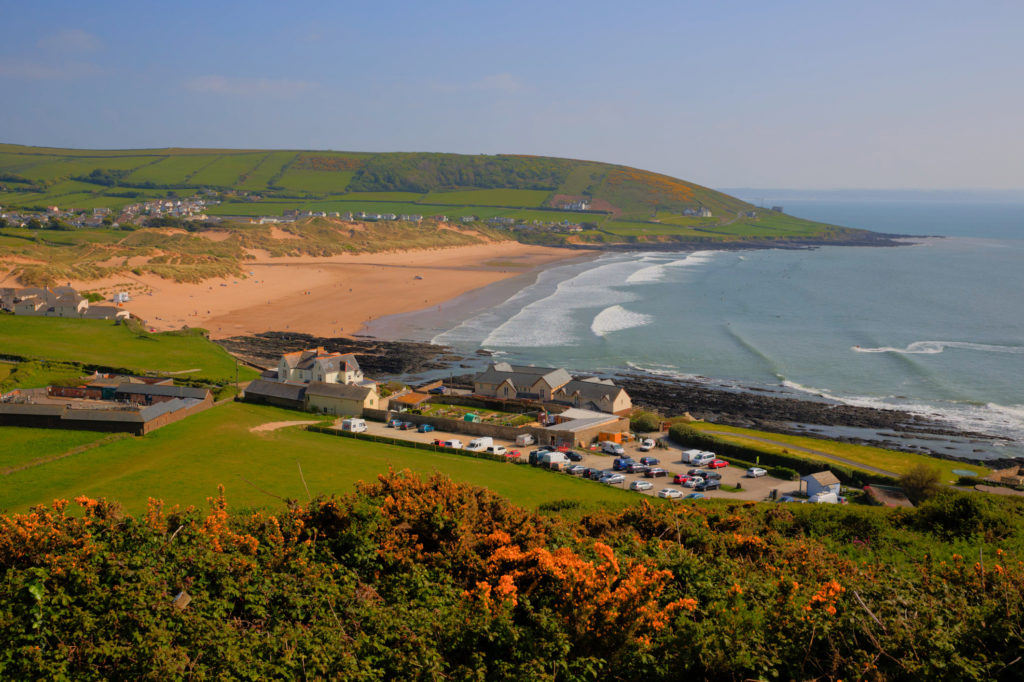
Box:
[217,332,1017,467]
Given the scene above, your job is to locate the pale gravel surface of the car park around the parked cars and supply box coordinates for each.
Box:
[367,420,800,501]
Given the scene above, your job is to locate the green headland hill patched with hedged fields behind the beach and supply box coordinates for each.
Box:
[0,144,863,244]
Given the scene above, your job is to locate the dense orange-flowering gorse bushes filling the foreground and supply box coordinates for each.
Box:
[0,473,1024,680]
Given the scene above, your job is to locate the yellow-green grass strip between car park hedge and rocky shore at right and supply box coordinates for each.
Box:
[689,422,988,483]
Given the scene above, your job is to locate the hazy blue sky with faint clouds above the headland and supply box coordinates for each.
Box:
[0,0,1024,189]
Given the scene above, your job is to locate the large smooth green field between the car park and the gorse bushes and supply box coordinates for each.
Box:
[0,402,636,513]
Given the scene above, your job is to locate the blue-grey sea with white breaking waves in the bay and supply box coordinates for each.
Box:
[368,198,1024,459]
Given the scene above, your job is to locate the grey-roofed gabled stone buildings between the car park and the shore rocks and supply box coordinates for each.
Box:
[473,363,633,415]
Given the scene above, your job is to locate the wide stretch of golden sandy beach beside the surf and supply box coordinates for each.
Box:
[56,242,590,338]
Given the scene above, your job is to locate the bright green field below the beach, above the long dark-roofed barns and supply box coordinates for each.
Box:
[0,315,256,383]
